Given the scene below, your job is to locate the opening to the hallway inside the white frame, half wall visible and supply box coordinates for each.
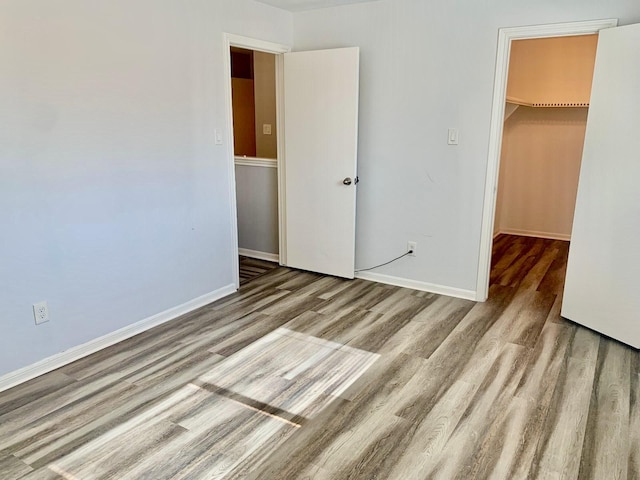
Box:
[230,46,280,284]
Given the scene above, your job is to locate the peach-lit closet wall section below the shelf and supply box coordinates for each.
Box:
[495,107,588,239]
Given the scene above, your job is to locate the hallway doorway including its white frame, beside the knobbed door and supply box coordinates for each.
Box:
[223,34,291,288]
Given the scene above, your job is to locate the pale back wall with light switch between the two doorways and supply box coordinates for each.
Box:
[294,0,640,290]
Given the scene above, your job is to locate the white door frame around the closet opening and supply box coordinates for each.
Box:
[476,19,618,302]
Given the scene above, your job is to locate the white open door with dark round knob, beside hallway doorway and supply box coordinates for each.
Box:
[284,47,359,278]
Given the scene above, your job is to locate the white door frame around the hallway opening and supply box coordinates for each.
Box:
[223,33,291,289]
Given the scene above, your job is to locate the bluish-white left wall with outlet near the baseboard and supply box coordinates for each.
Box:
[0,0,292,375]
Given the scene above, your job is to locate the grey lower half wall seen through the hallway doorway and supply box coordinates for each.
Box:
[236,165,279,254]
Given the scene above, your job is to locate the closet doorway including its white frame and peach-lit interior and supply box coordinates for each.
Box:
[477,20,617,301]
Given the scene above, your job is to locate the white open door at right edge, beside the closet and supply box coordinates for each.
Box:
[562,25,640,348]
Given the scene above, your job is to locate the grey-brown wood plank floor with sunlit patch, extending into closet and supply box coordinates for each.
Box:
[0,235,640,480]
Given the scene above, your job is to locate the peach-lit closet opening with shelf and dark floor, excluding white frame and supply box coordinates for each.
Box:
[489,34,598,301]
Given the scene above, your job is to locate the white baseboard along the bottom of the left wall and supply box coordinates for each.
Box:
[0,285,236,392]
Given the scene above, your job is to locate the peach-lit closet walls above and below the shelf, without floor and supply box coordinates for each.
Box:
[494,35,597,240]
